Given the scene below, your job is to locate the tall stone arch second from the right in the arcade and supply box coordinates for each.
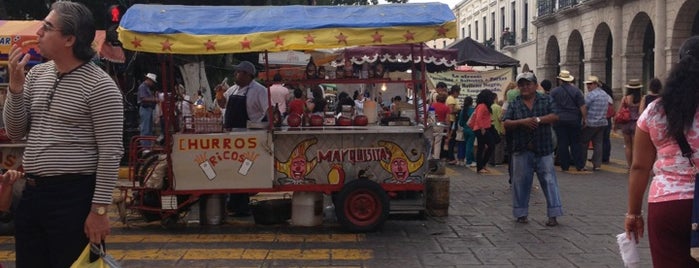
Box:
[624,12,655,84]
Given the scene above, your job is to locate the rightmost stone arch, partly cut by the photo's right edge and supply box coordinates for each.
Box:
[668,1,699,63]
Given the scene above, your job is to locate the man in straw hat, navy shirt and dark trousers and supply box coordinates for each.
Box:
[550,70,587,171]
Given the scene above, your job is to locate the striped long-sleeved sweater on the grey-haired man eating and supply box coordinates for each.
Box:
[3,61,124,204]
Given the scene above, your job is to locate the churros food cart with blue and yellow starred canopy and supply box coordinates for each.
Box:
[119,3,456,231]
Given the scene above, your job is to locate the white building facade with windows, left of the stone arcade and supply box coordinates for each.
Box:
[454,0,538,72]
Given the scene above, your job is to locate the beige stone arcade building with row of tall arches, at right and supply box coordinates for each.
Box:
[533,0,699,96]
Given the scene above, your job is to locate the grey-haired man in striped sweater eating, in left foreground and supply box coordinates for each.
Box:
[3,1,124,267]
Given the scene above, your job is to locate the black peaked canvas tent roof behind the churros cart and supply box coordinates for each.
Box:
[448,37,519,67]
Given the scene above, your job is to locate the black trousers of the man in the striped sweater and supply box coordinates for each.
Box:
[15,174,95,268]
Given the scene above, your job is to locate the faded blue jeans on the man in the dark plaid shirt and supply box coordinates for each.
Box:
[512,151,563,218]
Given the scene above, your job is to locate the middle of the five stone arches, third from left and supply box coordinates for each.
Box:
[588,22,613,86]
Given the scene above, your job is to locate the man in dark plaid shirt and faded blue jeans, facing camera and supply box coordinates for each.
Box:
[504,72,563,226]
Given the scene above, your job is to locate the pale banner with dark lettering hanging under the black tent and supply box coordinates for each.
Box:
[427,68,513,103]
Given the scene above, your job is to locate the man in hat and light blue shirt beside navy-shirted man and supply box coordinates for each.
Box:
[580,75,609,171]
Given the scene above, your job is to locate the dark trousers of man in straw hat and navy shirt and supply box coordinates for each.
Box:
[553,122,585,171]
